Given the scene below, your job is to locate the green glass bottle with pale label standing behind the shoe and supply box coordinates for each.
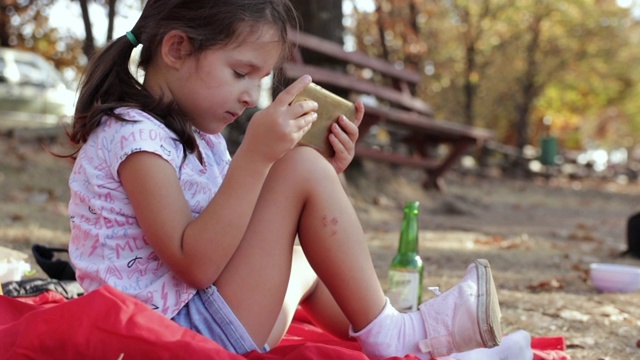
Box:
[387,201,424,312]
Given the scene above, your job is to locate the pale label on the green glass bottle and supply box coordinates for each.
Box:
[387,269,421,312]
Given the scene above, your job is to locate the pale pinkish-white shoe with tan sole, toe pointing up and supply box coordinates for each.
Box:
[418,259,502,357]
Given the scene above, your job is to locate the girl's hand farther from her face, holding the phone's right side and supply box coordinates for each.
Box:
[329,100,364,174]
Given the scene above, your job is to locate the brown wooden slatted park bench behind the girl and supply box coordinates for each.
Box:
[282,31,493,191]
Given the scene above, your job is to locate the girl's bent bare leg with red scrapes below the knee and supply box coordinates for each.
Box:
[216,147,385,346]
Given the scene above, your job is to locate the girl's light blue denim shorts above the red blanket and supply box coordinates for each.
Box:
[172,285,269,354]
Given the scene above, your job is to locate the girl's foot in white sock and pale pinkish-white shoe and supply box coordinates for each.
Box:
[349,260,502,359]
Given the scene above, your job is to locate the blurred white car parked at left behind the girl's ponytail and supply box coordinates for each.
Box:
[0,47,76,129]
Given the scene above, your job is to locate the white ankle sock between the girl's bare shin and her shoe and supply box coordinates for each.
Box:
[350,299,431,360]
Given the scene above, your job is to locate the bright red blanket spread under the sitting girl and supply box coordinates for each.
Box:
[0,286,569,360]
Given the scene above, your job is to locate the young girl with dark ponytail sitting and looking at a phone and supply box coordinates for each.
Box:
[69,0,501,359]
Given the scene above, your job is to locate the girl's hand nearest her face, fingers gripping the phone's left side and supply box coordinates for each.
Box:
[241,75,318,163]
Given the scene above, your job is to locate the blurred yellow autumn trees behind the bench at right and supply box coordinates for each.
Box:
[348,0,640,158]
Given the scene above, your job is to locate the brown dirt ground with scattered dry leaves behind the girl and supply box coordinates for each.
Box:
[0,130,640,360]
